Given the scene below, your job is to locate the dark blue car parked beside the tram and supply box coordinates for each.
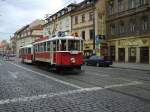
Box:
[84,56,113,67]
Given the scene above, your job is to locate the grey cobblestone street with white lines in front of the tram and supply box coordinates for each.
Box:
[0,61,150,112]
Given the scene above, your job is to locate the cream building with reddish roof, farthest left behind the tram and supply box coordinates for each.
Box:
[14,20,45,56]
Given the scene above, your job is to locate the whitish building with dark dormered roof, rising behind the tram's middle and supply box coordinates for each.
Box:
[43,4,76,36]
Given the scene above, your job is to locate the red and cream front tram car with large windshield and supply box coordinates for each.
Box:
[21,33,83,70]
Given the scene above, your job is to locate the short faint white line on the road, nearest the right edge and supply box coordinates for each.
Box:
[104,81,143,89]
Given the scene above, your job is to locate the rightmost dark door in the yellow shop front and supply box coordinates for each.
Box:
[140,47,149,63]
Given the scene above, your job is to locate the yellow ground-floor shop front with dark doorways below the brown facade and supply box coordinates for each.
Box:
[108,38,150,63]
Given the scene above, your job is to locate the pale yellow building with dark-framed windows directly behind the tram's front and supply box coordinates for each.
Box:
[71,0,95,56]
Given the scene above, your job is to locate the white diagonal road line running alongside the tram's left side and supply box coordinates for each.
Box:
[8,62,82,89]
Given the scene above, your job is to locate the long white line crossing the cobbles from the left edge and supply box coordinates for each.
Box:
[0,87,103,105]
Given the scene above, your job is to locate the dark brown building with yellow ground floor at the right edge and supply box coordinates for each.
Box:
[106,0,150,63]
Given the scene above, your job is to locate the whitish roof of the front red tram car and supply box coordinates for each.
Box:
[33,36,82,44]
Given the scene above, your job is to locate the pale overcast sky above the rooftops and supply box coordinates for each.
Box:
[0,0,83,41]
